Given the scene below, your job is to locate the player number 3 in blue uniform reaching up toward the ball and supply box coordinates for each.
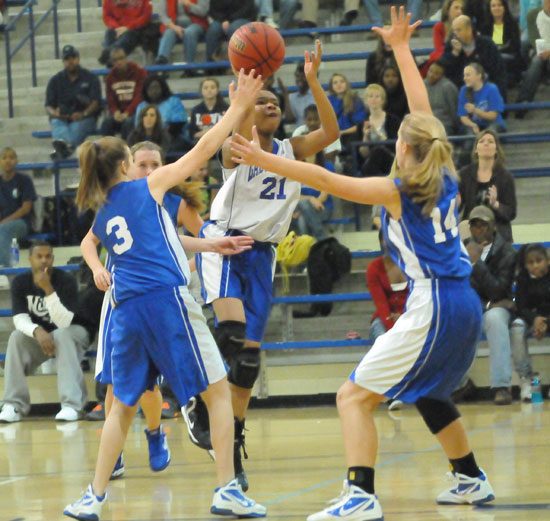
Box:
[64,71,266,521]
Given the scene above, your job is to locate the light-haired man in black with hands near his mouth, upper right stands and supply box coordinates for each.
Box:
[442,15,507,101]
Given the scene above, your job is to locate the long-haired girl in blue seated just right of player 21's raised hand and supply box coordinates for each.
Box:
[328,72,367,140]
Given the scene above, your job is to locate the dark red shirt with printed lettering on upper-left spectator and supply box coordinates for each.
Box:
[105,62,147,115]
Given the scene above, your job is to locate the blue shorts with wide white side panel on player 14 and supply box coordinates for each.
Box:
[350,279,482,403]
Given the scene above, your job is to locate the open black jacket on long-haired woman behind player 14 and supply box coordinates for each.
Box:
[458,163,517,242]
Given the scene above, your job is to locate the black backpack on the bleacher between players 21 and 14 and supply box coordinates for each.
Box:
[295,237,351,317]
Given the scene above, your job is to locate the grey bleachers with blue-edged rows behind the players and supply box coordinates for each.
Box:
[0,0,550,401]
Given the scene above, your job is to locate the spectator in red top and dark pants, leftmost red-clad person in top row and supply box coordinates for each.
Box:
[98,0,153,65]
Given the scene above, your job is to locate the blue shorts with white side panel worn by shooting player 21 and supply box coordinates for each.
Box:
[196,221,277,342]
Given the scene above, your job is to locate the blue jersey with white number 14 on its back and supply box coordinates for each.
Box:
[382,172,472,280]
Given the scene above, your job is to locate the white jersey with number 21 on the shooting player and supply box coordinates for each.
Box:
[210,139,301,244]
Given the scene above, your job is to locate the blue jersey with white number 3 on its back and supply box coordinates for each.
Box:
[92,179,190,303]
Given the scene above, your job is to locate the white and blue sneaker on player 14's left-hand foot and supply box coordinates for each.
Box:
[307,480,384,521]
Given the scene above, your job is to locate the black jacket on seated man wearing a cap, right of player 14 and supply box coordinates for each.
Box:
[470,233,516,308]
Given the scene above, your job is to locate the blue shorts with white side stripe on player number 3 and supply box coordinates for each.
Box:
[111,286,227,406]
